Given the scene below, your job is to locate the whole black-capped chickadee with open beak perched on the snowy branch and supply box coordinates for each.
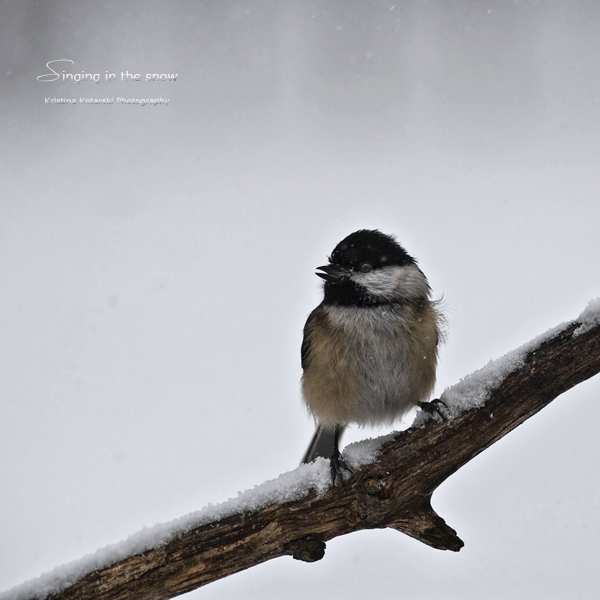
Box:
[302,229,443,485]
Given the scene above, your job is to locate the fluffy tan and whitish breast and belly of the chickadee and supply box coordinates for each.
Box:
[302,301,439,426]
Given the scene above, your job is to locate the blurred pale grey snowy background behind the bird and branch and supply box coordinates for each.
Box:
[0,0,600,600]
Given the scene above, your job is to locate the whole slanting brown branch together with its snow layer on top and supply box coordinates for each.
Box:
[0,299,600,600]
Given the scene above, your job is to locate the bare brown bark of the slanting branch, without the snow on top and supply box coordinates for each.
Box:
[14,322,600,600]
